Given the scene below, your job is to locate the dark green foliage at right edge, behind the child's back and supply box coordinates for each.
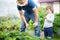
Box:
[53,13,60,34]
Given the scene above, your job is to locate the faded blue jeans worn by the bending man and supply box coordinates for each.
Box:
[20,13,40,37]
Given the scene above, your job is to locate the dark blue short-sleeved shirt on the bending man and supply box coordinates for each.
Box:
[17,0,37,14]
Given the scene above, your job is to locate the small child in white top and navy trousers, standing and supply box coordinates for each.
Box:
[43,6,54,39]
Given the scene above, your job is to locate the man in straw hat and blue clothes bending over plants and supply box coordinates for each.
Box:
[17,0,40,37]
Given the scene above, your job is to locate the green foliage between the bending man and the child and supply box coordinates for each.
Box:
[38,7,47,30]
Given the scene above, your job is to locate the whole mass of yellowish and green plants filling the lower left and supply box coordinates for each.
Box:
[0,17,40,40]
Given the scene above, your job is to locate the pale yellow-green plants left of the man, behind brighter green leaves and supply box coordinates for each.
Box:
[0,17,20,31]
